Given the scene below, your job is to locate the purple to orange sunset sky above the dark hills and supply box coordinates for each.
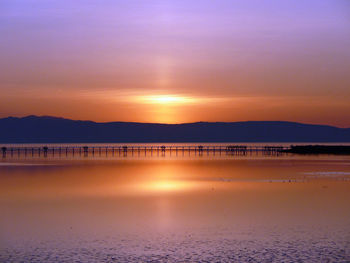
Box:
[0,0,350,127]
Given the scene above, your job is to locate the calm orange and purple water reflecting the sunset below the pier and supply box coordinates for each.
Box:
[0,147,350,262]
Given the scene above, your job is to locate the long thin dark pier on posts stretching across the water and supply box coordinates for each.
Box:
[1,145,290,158]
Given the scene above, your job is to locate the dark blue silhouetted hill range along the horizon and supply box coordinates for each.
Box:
[0,116,350,143]
